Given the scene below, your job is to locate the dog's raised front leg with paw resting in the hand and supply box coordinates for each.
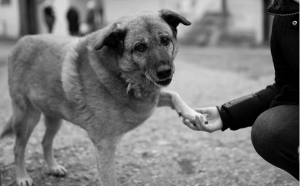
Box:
[157,90,202,122]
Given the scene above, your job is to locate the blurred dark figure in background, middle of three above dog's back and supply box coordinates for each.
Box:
[67,6,79,36]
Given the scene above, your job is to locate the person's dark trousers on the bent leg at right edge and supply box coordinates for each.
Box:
[251,105,299,180]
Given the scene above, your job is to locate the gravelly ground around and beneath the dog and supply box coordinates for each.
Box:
[0,41,299,186]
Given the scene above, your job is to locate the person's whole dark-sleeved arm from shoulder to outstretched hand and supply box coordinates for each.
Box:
[183,15,299,132]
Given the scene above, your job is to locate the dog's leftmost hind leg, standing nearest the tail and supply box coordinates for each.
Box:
[12,103,41,186]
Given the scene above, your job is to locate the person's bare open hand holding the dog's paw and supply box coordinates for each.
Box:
[182,107,223,133]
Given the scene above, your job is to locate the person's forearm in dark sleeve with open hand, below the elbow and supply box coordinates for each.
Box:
[183,84,281,132]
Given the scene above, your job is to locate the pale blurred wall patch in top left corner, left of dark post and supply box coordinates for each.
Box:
[0,0,20,38]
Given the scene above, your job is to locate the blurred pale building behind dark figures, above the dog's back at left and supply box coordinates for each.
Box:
[0,0,98,38]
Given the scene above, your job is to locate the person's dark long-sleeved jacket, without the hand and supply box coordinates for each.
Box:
[218,0,299,131]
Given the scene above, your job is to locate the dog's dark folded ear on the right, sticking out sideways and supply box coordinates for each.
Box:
[159,9,192,37]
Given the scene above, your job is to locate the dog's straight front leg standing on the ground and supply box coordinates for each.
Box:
[93,137,120,186]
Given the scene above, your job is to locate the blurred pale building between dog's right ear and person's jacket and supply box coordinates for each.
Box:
[175,0,272,46]
